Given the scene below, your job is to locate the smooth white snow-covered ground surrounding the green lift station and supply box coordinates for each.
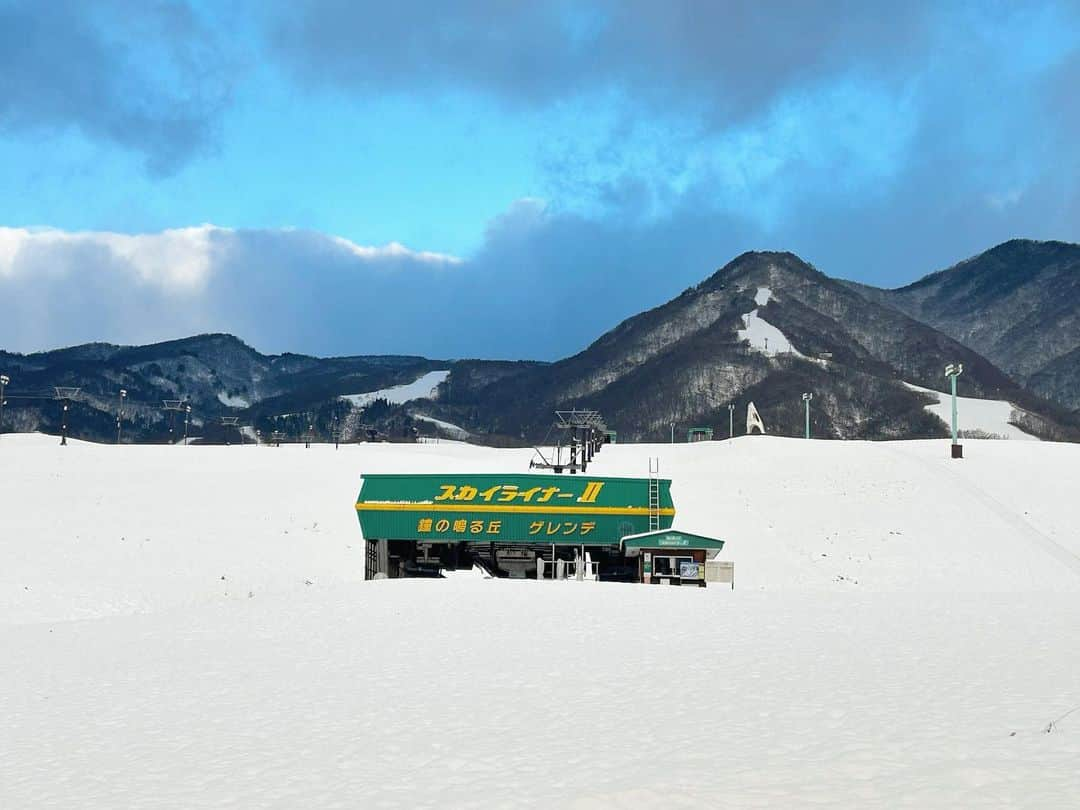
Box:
[0,435,1080,808]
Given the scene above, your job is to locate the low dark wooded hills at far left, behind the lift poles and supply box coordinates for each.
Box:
[0,334,447,441]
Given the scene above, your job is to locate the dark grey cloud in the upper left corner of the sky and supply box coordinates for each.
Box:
[0,0,229,174]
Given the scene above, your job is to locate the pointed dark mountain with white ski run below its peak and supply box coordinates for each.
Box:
[429,253,1080,440]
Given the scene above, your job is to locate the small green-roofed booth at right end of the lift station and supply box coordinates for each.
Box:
[621,529,734,588]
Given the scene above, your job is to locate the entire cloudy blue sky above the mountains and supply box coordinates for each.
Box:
[0,0,1080,359]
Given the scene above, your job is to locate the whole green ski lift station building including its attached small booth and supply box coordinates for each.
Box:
[356,474,724,584]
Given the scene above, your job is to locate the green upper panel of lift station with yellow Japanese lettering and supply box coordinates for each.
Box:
[356,474,675,545]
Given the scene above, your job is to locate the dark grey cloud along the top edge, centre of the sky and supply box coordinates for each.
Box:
[270,0,932,123]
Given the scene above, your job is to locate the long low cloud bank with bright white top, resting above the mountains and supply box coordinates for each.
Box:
[0,212,759,360]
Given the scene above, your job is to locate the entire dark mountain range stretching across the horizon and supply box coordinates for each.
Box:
[0,240,1080,444]
